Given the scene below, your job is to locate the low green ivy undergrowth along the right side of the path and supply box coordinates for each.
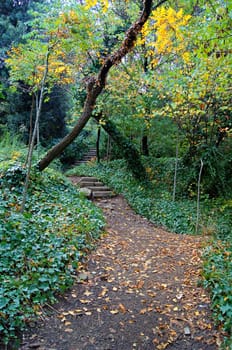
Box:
[68,158,232,349]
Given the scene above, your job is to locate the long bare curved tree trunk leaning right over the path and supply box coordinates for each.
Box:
[38,0,167,171]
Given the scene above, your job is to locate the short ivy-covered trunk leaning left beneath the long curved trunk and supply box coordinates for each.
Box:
[94,117,147,180]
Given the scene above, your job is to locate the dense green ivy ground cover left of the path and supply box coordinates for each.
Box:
[0,161,104,341]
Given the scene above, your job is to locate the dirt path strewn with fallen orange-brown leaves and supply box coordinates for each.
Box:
[21,196,219,350]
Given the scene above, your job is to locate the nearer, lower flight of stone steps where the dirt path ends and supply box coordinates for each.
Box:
[76,176,114,199]
